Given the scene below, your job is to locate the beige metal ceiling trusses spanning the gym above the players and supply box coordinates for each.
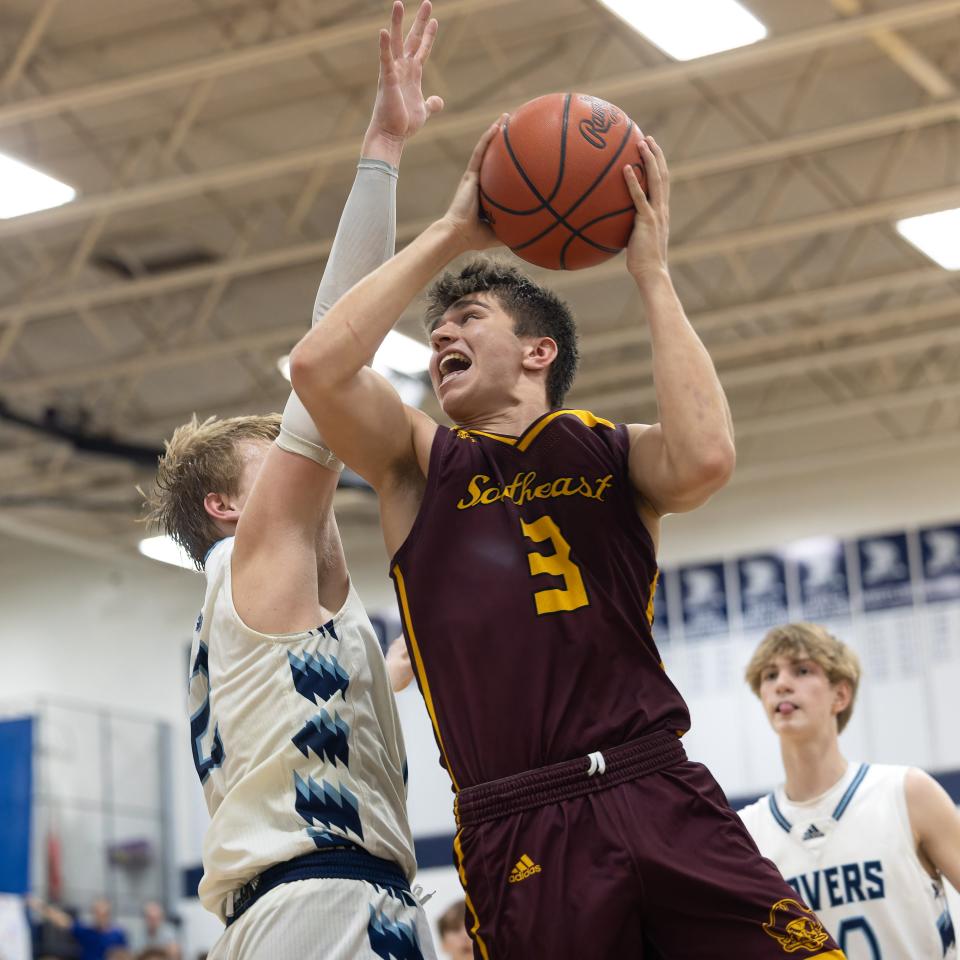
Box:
[0,0,960,556]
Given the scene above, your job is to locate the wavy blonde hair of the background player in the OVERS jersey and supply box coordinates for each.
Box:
[744,623,861,733]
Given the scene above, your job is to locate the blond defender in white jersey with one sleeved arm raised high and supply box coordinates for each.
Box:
[142,2,442,960]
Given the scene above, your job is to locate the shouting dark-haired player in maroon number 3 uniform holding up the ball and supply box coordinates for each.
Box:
[291,124,842,960]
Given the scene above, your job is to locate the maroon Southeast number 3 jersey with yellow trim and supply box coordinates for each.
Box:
[391,410,690,790]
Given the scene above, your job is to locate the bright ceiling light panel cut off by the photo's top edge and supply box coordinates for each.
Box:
[600,0,767,60]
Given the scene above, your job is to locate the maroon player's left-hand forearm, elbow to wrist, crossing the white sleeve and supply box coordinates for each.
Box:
[290,220,466,396]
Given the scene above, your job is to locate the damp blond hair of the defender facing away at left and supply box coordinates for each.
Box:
[140,413,280,570]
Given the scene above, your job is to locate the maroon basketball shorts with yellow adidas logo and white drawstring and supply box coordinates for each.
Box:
[454,732,843,960]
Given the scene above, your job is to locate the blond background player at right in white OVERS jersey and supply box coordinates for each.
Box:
[740,623,960,960]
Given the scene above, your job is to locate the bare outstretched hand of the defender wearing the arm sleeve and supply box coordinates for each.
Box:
[364,0,443,155]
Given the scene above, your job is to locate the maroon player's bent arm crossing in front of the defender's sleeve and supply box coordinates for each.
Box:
[290,118,499,502]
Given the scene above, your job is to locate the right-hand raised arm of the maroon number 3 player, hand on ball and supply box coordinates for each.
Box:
[624,137,736,515]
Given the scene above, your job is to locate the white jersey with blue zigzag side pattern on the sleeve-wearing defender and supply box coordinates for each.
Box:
[190,537,416,920]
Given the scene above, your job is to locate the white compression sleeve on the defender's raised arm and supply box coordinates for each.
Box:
[277,159,397,470]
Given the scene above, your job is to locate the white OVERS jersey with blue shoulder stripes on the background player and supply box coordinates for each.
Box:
[740,763,957,960]
